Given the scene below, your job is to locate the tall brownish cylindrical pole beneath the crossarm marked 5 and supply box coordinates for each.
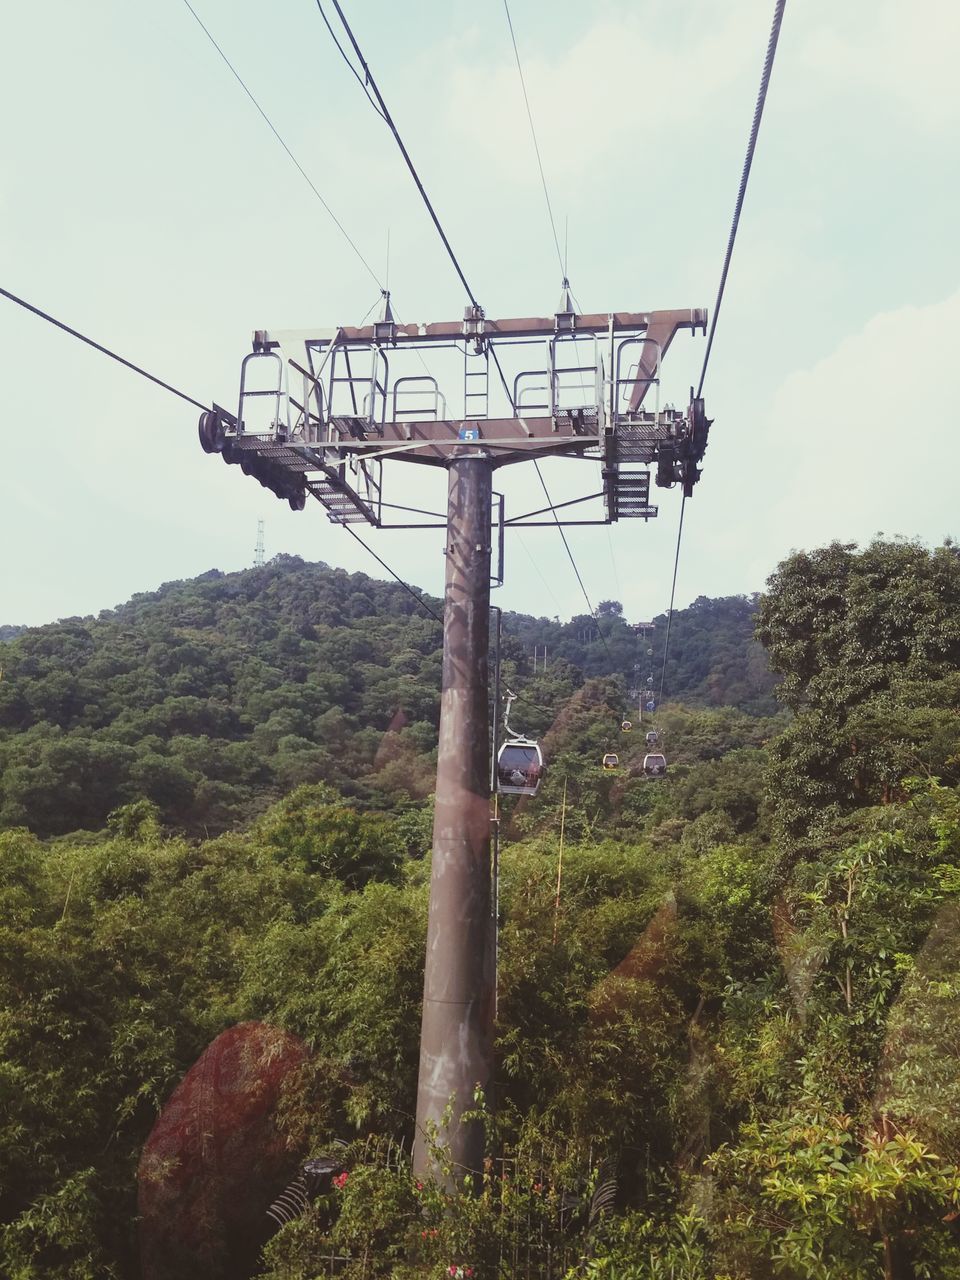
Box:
[413,456,494,1185]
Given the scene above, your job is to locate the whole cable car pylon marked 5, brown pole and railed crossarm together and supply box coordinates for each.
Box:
[200,291,709,1187]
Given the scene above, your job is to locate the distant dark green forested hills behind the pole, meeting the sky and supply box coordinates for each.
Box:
[0,557,774,836]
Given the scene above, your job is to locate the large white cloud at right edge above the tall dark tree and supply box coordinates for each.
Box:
[763,291,960,547]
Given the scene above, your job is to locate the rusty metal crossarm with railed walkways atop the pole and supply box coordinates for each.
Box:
[201,293,709,527]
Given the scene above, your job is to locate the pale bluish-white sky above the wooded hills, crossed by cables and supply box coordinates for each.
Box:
[0,0,960,625]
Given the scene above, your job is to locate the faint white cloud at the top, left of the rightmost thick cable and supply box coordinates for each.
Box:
[448,0,767,185]
